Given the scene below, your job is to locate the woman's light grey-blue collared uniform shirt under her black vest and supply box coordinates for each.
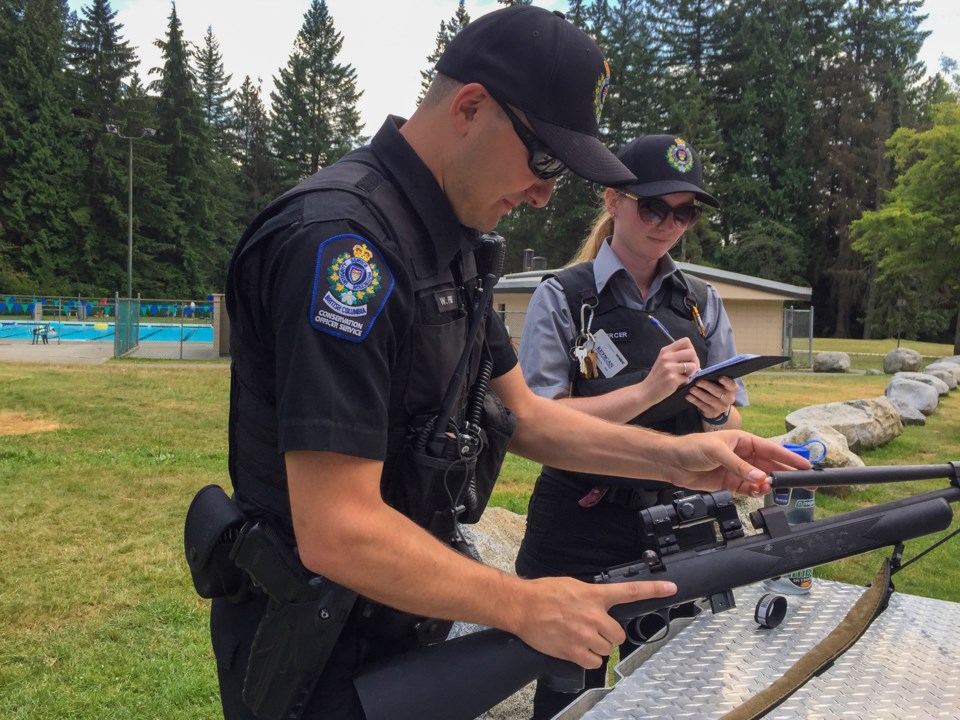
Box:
[518,238,749,406]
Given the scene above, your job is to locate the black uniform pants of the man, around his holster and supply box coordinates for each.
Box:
[210,593,409,720]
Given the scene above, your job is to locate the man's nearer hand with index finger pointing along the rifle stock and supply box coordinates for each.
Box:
[513,577,677,669]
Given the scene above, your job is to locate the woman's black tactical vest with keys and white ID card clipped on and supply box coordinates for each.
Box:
[544,261,707,492]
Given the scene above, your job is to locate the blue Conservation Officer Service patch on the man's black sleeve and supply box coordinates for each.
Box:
[310,235,393,342]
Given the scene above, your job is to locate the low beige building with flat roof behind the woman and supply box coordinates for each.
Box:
[493,263,812,355]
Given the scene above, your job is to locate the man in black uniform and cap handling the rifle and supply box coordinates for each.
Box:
[211,6,806,718]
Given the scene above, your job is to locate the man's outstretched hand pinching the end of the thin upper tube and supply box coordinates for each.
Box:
[665,430,810,497]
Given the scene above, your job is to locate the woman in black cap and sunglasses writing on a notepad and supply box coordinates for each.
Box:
[517,135,746,719]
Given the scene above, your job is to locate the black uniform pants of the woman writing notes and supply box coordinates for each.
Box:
[516,474,712,720]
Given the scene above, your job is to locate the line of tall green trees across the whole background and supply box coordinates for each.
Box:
[0,0,960,343]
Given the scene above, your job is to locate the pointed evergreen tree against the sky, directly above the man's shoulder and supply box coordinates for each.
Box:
[270,0,363,185]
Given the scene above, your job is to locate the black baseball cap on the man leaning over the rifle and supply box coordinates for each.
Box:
[437,5,636,185]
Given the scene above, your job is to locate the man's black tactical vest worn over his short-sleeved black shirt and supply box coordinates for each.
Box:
[230,153,479,537]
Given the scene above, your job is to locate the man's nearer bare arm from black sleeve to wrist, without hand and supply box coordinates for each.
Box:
[286,452,529,632]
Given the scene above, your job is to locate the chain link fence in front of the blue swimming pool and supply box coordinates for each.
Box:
[0,294,220,360]
